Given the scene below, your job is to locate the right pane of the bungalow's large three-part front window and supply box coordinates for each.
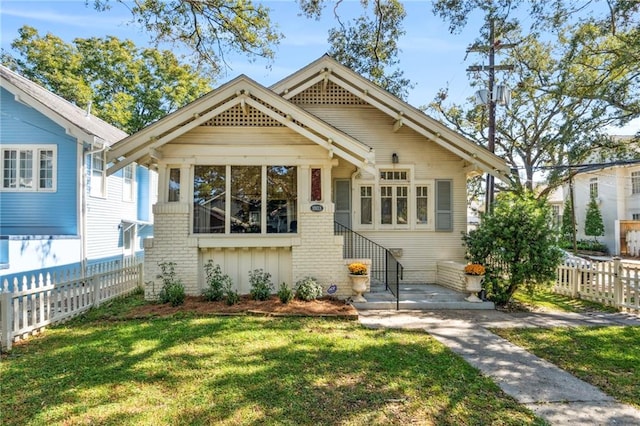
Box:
[267,166,296,233]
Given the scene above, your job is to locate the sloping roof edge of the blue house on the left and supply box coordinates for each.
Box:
[0,65,127,146]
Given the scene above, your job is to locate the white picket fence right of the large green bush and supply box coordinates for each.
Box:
[553,259,640,313]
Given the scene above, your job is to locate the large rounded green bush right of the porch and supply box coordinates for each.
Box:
[463,192,562,305]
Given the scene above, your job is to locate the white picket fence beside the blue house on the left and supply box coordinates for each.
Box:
[0,258,143,350]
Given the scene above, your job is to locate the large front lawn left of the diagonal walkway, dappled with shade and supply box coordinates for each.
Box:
[0,297,544,425]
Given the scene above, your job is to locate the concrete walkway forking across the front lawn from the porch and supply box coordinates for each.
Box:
[358,310,640,425]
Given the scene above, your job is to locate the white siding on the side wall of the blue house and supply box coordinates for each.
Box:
[87,170,140,260]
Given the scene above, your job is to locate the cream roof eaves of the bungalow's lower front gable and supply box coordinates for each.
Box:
[107,75,375,174]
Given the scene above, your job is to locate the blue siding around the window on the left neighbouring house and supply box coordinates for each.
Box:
[0,89,79,236]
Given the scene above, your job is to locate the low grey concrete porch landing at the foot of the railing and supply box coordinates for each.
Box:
[353,283,495,310]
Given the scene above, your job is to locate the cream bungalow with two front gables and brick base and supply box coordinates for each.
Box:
[107,56,509,297]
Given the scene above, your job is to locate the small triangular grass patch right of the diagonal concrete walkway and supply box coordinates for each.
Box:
[492,327,640,408]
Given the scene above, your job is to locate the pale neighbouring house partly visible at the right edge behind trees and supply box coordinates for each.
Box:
[565,136,640,255]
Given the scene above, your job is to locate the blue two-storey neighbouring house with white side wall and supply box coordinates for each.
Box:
[0,66,157,281]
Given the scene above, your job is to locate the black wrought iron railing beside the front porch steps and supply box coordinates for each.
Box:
[334,222,403,308]
